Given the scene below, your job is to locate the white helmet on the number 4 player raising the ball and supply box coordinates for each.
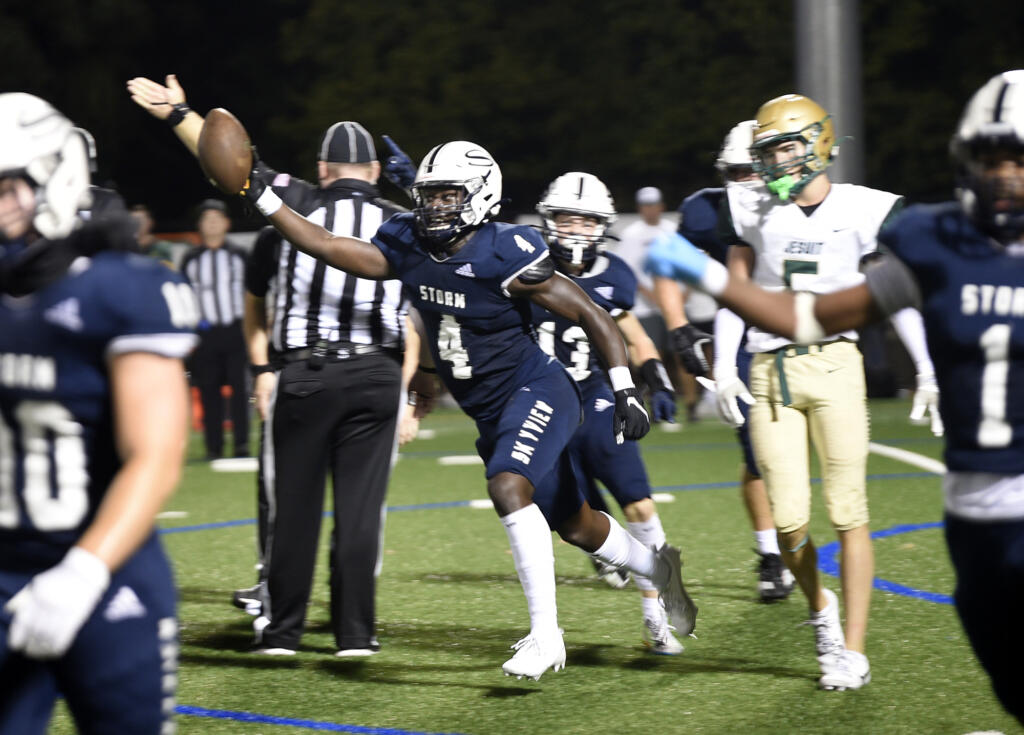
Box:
[412,140,502,251]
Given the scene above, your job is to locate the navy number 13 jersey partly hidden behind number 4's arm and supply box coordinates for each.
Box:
[532,253,637,390]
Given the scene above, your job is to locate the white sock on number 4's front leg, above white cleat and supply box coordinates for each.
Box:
[501,503,558,635]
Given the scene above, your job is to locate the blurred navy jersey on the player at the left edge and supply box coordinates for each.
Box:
[0,247,198,570]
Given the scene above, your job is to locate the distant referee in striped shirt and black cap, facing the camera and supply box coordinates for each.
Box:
[181,199,249,460]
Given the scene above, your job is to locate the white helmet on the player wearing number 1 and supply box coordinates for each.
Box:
[949,70,1024,242]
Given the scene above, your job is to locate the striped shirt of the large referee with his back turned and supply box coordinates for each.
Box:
[246,172,408,353]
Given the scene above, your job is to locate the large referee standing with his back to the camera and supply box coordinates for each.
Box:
[246,122,406,656]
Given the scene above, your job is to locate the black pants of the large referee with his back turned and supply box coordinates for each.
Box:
[258,353,401,649]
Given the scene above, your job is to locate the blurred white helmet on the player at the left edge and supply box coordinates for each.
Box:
[0,92,90,240]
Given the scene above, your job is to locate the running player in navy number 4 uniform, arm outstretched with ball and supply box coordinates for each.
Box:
[234,140,696,679]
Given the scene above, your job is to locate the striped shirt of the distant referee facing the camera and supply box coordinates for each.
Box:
[181,241,246,327]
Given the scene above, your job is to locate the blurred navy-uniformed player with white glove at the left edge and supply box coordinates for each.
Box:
[0,93,197,735]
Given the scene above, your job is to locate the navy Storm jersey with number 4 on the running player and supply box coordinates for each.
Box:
[373,213,551,420]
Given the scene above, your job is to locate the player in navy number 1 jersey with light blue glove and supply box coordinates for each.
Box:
[650,70,1024,723]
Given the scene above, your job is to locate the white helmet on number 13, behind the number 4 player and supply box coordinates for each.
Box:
[537,171,615,265]
